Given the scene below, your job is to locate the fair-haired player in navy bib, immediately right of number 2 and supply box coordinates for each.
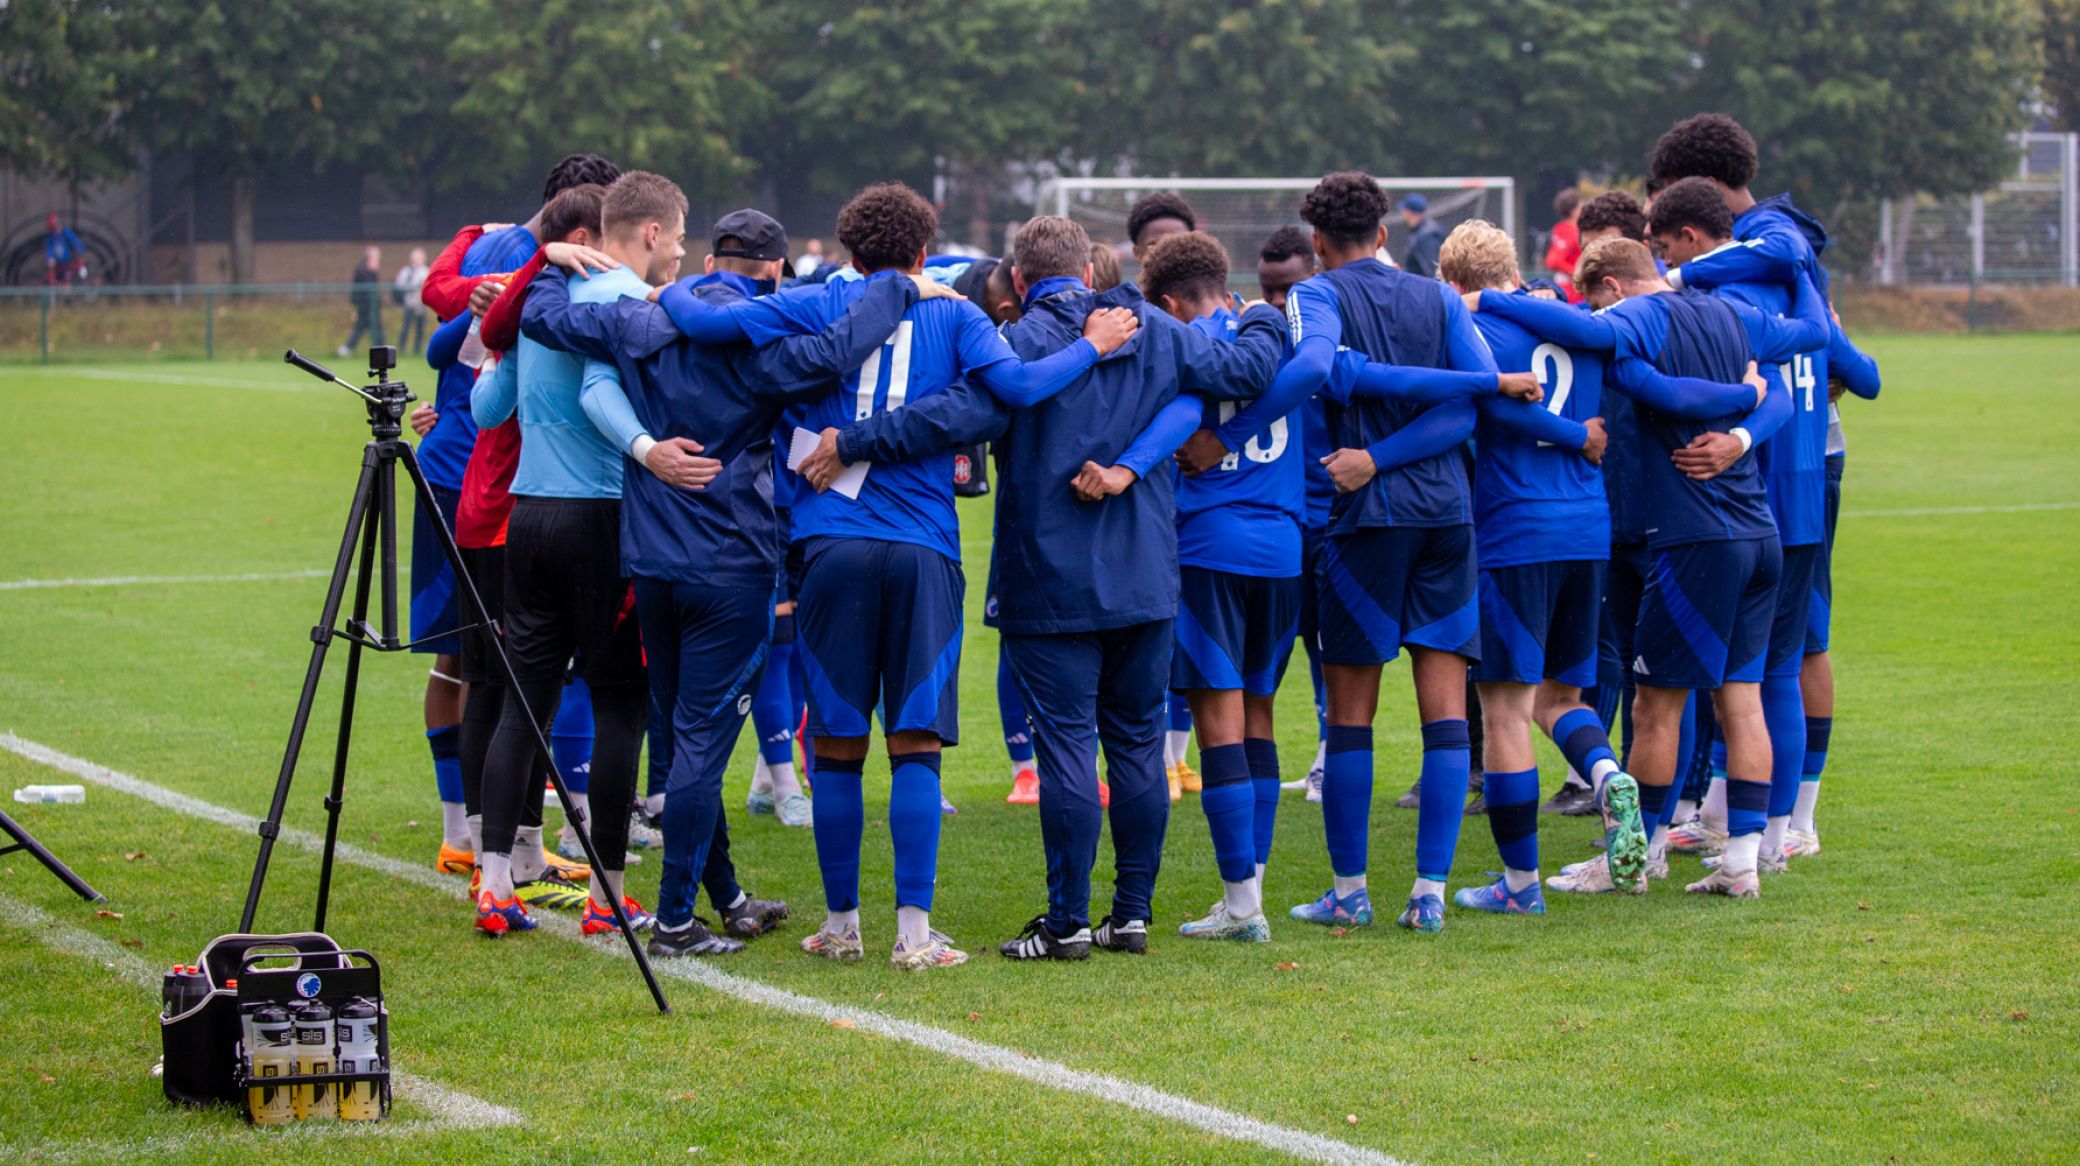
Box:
[1479,239,1828,898]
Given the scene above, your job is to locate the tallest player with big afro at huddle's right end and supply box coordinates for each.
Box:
[1649,114,1874,854]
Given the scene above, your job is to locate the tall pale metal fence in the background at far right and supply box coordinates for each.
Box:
[1872,133,2080,287]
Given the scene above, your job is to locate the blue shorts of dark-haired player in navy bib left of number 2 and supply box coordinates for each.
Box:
[1317,526,1481,665]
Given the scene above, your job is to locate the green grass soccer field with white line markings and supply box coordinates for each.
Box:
[0,337,2080,1164]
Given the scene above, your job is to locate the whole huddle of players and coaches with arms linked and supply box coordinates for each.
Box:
[397,114,1878,969]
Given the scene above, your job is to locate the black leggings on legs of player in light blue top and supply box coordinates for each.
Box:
[482,680,649,871]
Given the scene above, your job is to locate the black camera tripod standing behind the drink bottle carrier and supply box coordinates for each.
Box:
[244,347,672,1012]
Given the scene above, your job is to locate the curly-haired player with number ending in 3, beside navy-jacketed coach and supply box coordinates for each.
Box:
[1142,231,1304,944]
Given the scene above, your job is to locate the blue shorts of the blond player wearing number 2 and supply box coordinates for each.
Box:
[1473,559,1608,688]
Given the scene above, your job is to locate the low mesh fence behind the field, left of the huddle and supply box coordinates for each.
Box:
[0,283,435,364]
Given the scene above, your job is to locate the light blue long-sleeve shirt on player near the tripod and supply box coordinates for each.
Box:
[470,266,649,499]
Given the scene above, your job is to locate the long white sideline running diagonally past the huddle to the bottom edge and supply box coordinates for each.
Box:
[0,734,1408,1166]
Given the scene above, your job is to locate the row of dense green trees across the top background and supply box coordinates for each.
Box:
[0,0,2046,279]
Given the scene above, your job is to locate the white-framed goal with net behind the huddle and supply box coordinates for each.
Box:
[1034,177,1520,291]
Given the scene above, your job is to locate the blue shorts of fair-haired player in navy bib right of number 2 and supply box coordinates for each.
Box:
[1633,534,1783,690]
